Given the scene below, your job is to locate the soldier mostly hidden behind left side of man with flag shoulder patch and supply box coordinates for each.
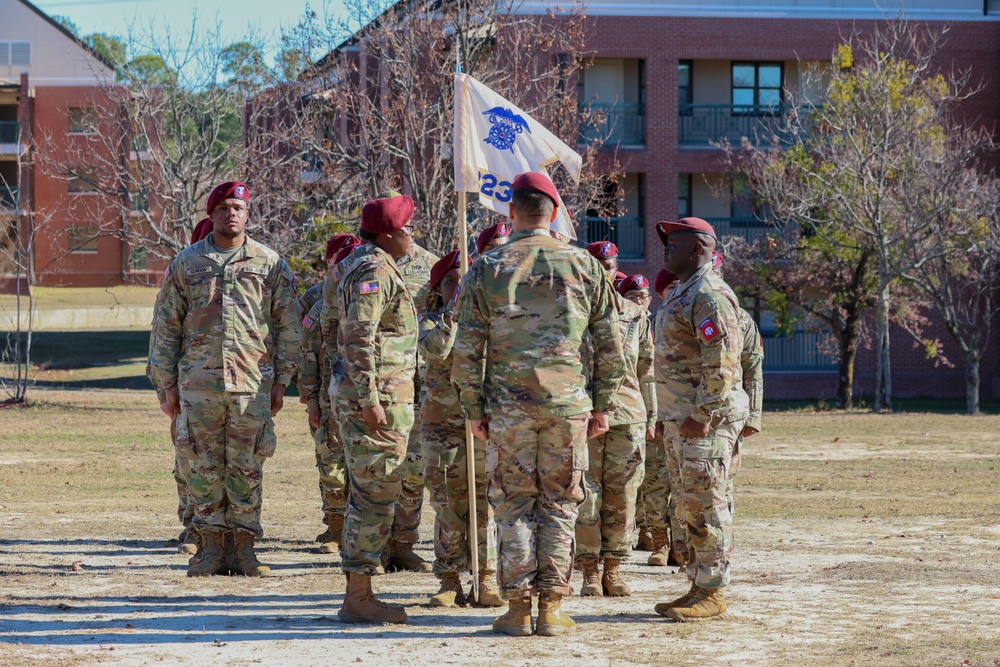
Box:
[296,234,360,554]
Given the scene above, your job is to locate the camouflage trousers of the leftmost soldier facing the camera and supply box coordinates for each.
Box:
[176,387,278,537]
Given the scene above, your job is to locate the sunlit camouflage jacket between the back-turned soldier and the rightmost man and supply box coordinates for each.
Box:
[609,294,656,426]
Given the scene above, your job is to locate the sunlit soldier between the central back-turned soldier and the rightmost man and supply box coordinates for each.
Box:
[576,275,656,597]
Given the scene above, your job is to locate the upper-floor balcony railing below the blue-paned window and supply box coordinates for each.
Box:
[679,104,812,146]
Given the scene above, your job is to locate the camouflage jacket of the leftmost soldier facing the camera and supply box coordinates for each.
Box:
[149,234,302,393]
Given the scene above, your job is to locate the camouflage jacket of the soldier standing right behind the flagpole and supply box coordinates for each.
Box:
[417,303,465,429]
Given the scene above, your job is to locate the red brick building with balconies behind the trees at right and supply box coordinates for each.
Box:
[560,0,1000,400]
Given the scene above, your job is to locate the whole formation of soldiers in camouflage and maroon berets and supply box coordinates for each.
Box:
[148,173,763,636]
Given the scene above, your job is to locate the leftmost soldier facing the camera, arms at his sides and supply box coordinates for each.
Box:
[149,182,301,576]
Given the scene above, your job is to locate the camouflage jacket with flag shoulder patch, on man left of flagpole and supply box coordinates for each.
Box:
[337,244,417,408]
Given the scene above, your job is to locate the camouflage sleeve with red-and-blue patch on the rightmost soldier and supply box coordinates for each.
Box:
[691,298,742,424]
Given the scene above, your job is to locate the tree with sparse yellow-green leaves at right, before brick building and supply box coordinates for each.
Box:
[730,21,977,411]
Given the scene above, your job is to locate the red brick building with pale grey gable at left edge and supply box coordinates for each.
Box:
[0,0,156,289]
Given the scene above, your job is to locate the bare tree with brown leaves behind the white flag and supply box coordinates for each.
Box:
[286,0,620,252]
